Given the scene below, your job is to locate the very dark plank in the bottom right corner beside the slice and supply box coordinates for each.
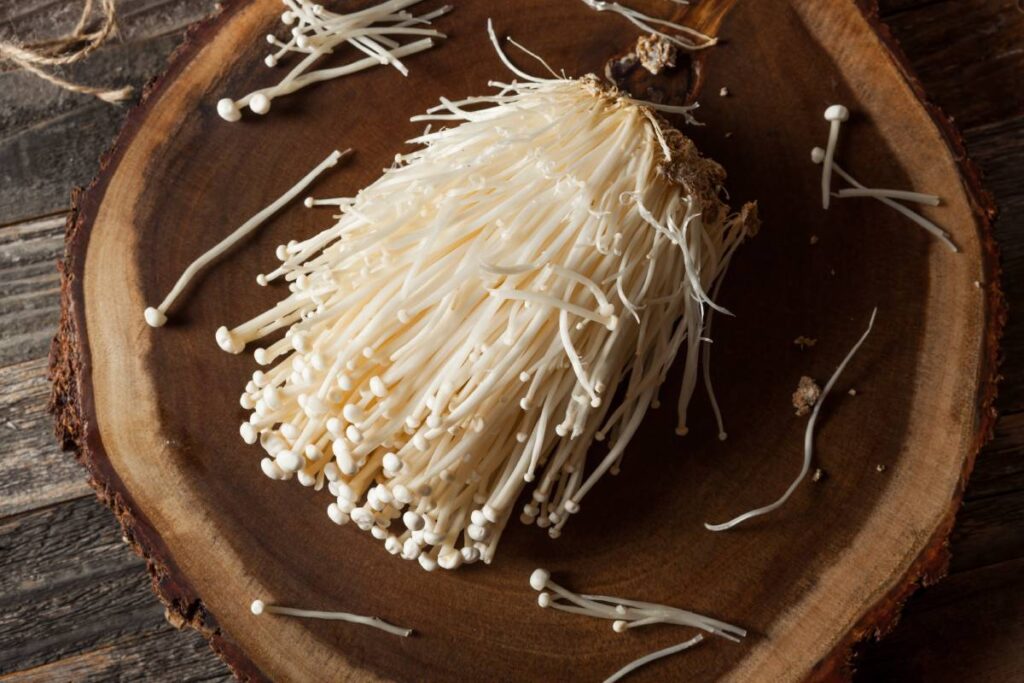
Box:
[856,559,1024,683]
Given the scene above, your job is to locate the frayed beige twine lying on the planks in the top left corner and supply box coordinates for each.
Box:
[0,0,132,102]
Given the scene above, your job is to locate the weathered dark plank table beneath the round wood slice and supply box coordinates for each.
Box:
[0,0,1024,681]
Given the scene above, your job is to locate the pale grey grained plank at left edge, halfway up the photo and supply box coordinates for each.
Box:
[0,216,65,368]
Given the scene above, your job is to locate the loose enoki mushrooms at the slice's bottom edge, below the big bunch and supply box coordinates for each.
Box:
[529,569,746,683]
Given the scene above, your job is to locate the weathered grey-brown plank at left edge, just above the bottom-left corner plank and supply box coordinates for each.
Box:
[0,358,91,511]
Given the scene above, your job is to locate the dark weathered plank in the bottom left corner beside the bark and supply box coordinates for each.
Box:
[0,491,225,680]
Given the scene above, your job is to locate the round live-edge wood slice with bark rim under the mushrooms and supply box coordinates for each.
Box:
[51,0,1004,681]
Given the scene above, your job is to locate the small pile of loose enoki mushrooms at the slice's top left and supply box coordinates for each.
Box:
[217,0,452,121]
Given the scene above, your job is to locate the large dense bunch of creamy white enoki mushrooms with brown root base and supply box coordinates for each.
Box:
[217,49,756,570]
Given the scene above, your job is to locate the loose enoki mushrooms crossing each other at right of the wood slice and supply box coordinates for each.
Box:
[811,104,959,252]
